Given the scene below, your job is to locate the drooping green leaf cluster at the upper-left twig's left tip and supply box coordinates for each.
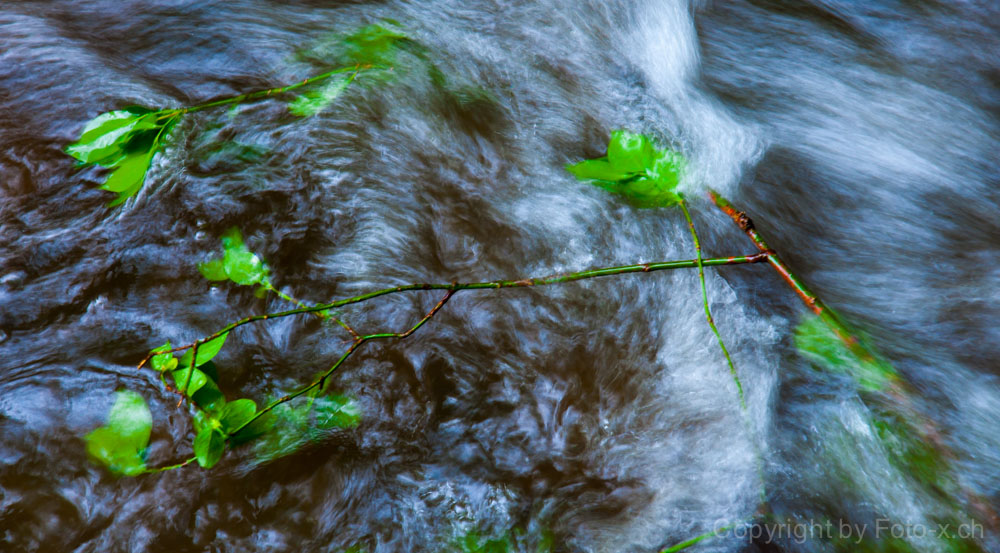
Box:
[66,106,180,206]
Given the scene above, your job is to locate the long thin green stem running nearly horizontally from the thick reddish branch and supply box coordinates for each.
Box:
[138,253,767,369]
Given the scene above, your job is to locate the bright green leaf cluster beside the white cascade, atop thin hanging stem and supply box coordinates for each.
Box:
[566,130,685,207]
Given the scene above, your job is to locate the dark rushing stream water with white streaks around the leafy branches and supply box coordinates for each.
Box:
[0,0,1000,552]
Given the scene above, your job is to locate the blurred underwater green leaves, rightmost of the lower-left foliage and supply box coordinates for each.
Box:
[252,395,361,462]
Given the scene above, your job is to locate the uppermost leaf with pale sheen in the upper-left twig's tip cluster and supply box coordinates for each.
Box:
[66,110,156,164]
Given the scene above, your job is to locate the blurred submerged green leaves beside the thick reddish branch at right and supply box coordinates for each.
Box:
[795,316,899,391]
